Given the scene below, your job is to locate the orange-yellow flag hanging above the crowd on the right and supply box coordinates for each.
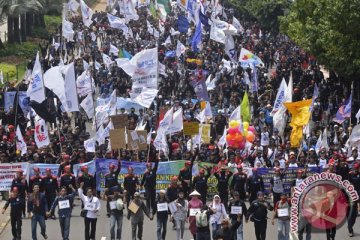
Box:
[284,99,312,148]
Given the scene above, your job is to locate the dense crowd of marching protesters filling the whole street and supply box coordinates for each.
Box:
[0,0,360,240]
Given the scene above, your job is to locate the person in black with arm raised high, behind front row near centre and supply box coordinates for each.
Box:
[140,161,159,212]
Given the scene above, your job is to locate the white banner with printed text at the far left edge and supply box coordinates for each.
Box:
[0,162,29,191]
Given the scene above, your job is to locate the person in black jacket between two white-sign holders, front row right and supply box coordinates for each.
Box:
[246,192,273,240]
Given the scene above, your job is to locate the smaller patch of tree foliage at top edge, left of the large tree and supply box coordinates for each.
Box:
[229,0,291,32]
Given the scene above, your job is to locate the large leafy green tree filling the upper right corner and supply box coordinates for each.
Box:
[281,0,360,79]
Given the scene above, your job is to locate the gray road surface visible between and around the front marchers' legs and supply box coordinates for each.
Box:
[0,200,360,240]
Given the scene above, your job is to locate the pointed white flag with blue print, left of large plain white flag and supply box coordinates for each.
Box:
[27,52,45,103]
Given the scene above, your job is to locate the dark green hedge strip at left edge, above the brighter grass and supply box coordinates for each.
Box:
[0,42,38,58]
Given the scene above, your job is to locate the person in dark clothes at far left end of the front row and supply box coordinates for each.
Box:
[1,187,25,240]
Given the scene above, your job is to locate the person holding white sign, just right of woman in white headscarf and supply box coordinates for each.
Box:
[229,191,247,240]
